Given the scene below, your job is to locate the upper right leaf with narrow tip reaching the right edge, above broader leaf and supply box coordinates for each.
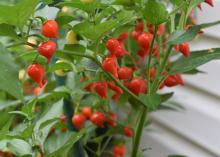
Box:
[167,21,220,45]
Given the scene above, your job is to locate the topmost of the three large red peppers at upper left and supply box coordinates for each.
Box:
[41,20,58,39]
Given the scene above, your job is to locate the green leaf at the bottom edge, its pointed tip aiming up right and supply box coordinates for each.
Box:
[45,130,85,157]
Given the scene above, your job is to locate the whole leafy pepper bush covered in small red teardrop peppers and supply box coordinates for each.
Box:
[0,0,217,157]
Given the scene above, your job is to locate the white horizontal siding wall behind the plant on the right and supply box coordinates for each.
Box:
[142,1,220,157]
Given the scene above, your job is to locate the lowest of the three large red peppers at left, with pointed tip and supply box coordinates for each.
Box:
[27,63,45,88]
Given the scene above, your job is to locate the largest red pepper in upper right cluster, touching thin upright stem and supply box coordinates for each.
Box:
[137,32,153,49]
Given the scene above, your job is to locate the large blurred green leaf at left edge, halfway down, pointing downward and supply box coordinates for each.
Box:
[0,44,23,100]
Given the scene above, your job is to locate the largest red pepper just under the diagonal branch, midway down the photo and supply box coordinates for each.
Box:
[94,82,108,99]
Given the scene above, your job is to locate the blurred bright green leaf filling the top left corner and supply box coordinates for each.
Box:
[0,0,38,29]
